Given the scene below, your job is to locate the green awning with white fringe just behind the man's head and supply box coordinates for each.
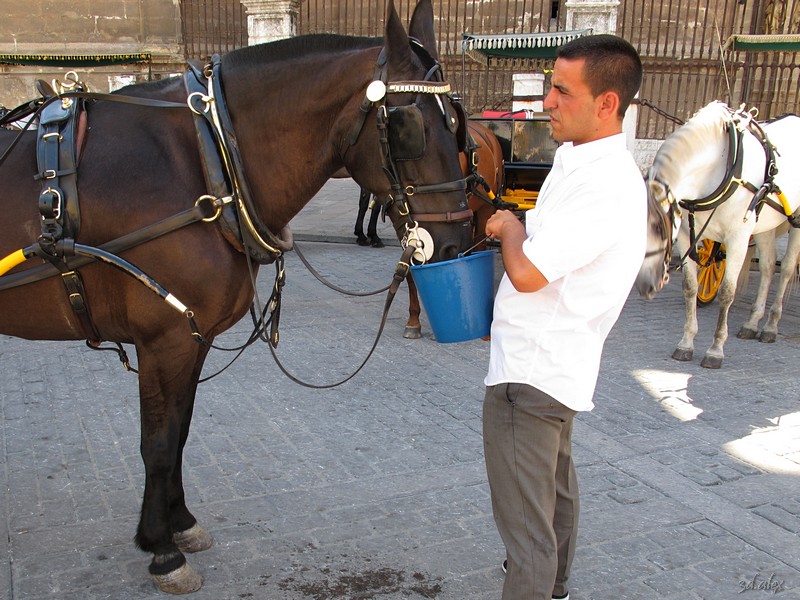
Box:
[461,29,592,64]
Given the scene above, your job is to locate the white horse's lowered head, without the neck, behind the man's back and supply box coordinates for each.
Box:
[636,169,680,300]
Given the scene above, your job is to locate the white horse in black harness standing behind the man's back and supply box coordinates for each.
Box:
[636,101,800,368]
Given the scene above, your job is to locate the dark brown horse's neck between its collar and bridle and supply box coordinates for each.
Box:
[225,52,374,228]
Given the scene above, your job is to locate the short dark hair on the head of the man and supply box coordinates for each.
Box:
[557,33,642,117]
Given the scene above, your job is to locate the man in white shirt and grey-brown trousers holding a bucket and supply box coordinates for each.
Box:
[483,35,647,600]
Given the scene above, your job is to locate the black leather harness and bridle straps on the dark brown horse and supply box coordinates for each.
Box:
[0,43,472,356]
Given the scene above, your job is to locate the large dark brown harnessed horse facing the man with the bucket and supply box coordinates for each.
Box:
[0,0,472,593]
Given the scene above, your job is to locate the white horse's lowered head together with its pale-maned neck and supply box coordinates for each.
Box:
[636,101,731,299]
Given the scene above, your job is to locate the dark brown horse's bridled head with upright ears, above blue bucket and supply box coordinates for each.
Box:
[342,0,472,263]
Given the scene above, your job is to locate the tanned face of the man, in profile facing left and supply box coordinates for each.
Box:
[544,58,598,146]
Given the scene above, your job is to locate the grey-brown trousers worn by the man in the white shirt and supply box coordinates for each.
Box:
[483,383,579,600]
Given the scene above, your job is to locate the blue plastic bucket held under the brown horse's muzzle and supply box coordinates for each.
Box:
[411,250,495,343]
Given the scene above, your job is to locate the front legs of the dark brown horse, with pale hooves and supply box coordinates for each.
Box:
[136,330,211,594]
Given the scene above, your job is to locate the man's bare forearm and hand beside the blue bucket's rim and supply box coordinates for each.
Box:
[486,210,549,292]
